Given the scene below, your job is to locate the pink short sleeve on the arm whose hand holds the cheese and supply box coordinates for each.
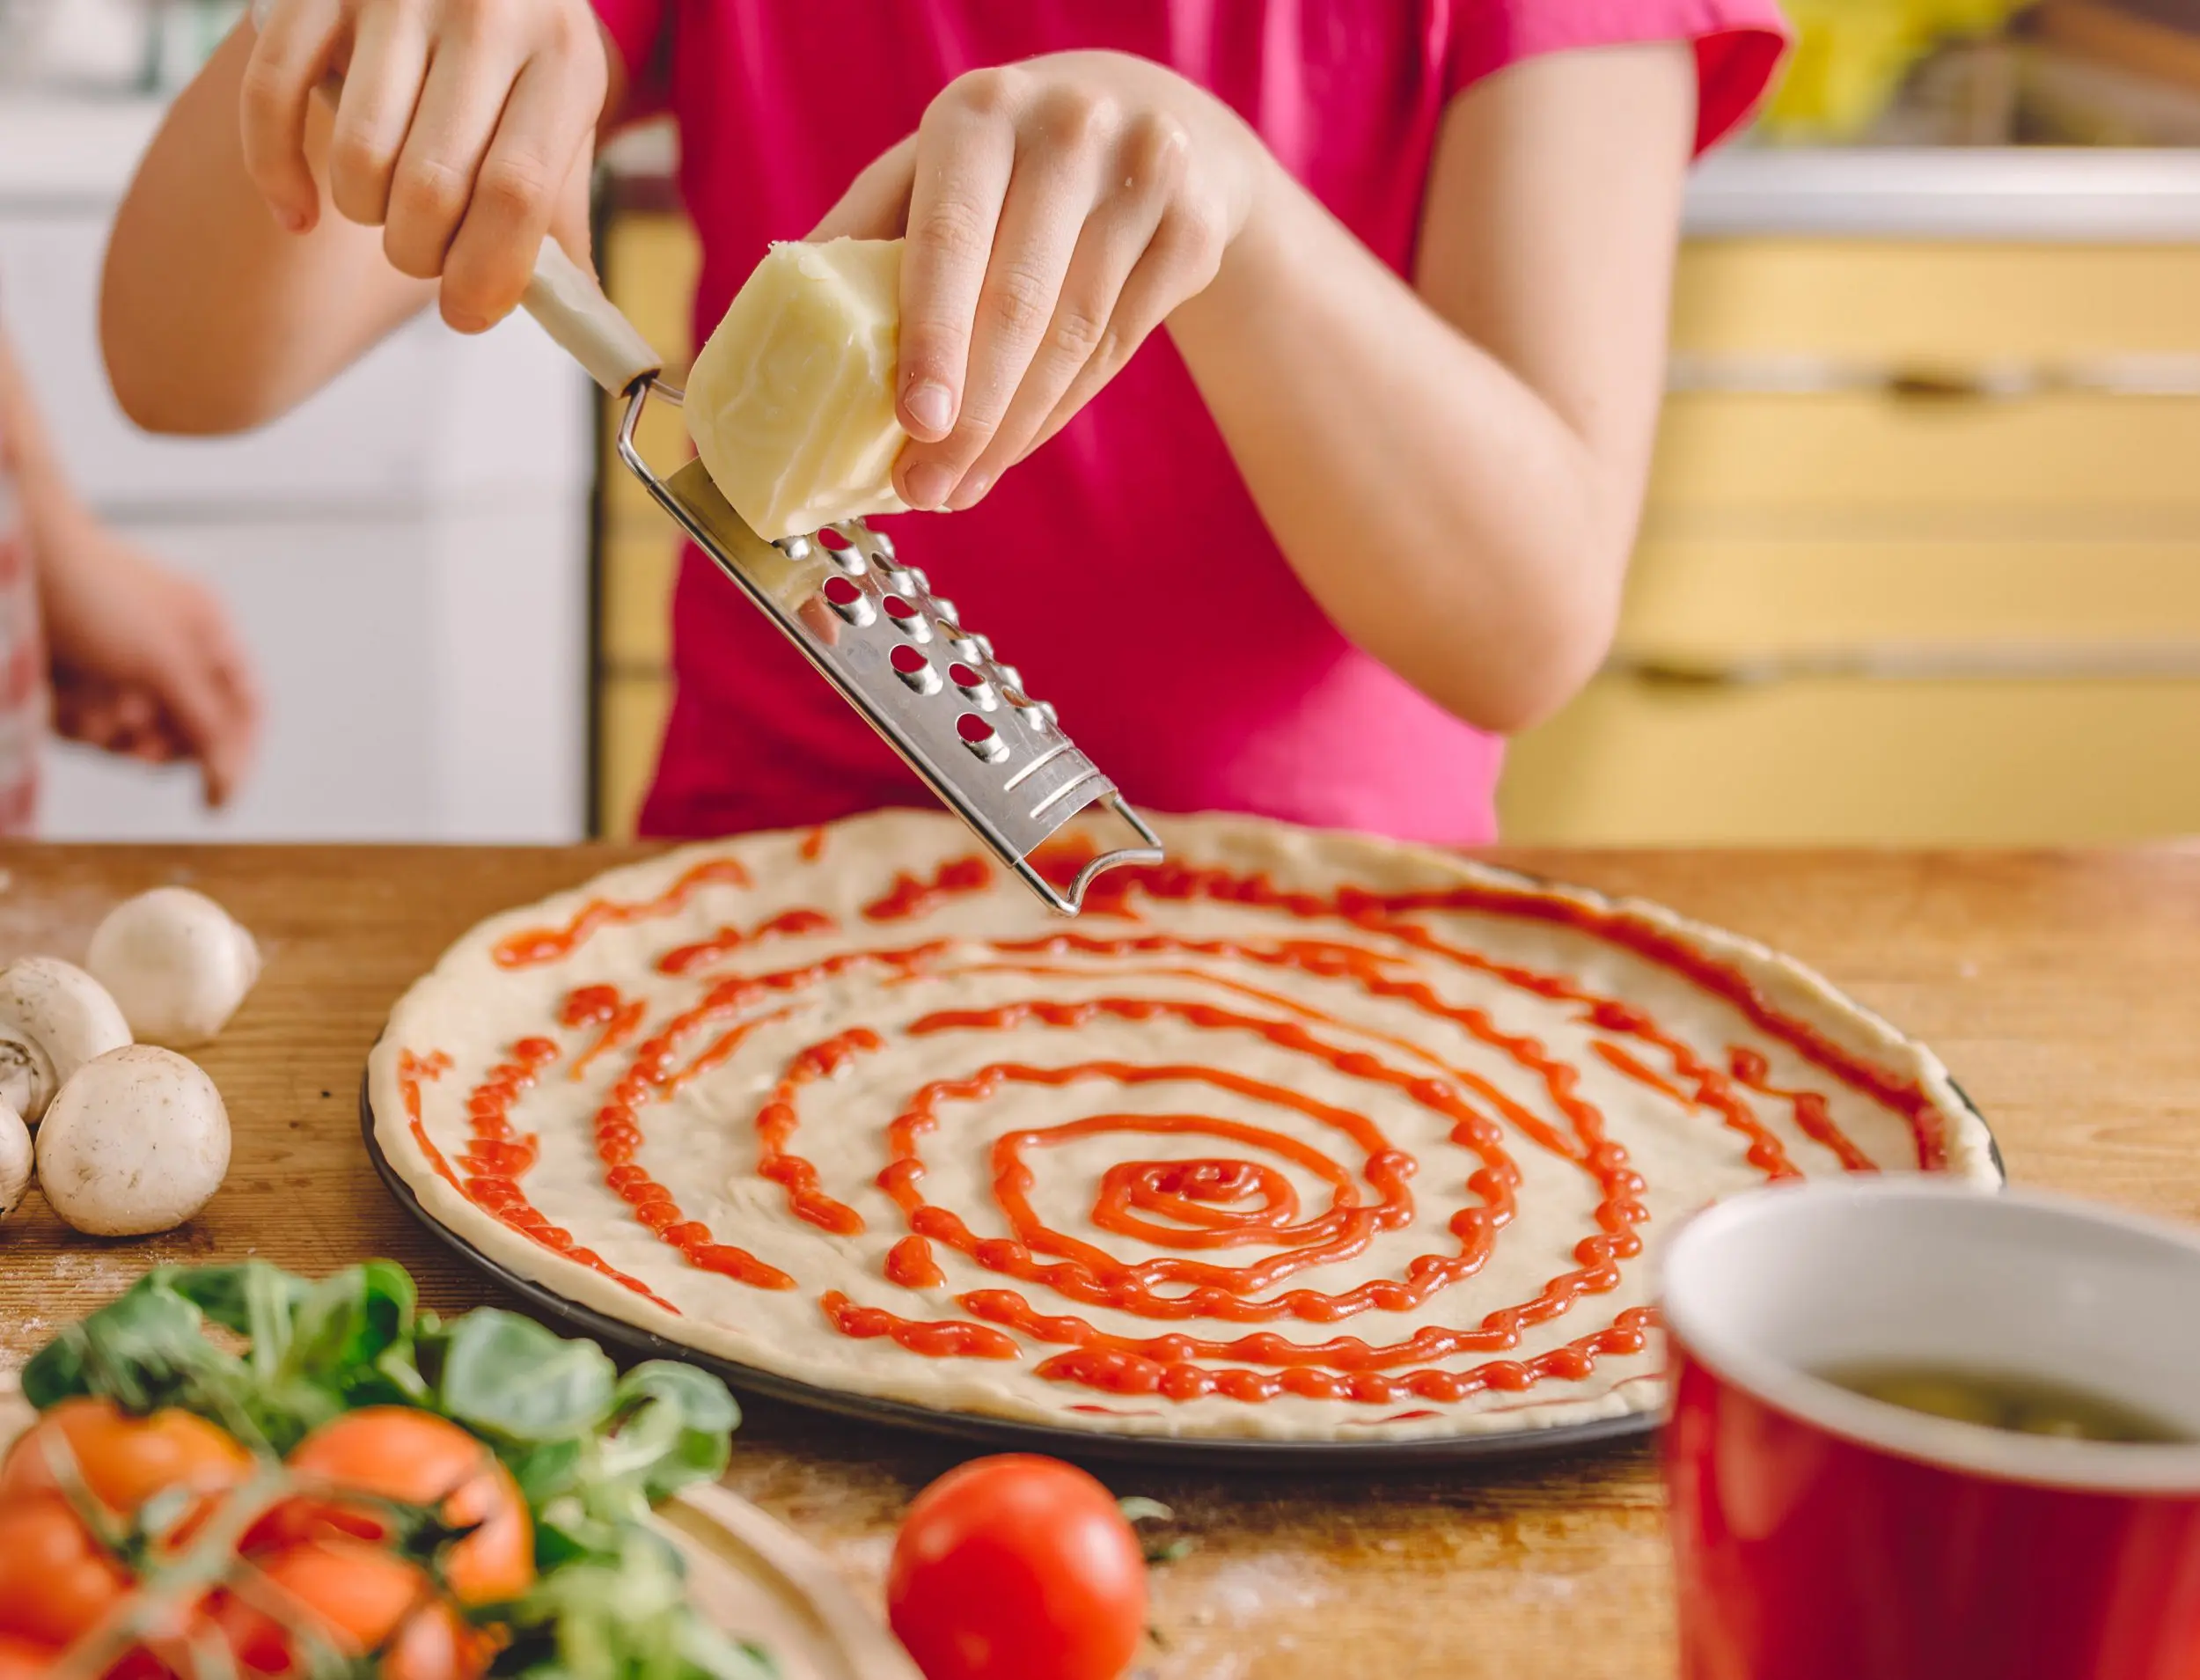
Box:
[1452,0,1789,154]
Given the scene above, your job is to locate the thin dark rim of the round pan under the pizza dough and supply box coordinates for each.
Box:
[359,1077,2009,1476]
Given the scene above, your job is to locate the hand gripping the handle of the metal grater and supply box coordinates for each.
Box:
[242,0,607,332]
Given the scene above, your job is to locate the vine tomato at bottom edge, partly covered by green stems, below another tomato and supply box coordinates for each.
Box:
[209,1539,491,1680]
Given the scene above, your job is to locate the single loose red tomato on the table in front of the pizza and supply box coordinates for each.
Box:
[887,1454,1147,1680]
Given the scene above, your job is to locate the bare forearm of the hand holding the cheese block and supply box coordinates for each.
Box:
[1169,169,1639,730]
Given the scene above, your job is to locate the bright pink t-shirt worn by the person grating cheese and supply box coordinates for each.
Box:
[597,0,1782,844]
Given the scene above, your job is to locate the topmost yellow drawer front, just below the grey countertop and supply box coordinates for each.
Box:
[1672,239,2200,363]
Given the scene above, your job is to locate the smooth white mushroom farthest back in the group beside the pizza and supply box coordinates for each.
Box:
[84,886,260,1045]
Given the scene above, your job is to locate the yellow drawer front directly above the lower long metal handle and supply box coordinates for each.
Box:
[1619,534,2200,660]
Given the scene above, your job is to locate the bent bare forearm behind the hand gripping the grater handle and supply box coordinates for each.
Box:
[99,24,434,433]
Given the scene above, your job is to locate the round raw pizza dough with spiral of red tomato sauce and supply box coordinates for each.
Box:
[370,811,1998,1438]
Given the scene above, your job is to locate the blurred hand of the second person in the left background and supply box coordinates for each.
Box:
[38,519,260,805]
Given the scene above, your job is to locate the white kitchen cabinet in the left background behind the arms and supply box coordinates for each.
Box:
[0,95,592,842]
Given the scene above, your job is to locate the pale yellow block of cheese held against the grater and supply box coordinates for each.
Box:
[686,239,909,541]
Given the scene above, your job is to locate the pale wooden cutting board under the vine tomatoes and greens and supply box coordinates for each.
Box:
[0,1376,920,1680]
